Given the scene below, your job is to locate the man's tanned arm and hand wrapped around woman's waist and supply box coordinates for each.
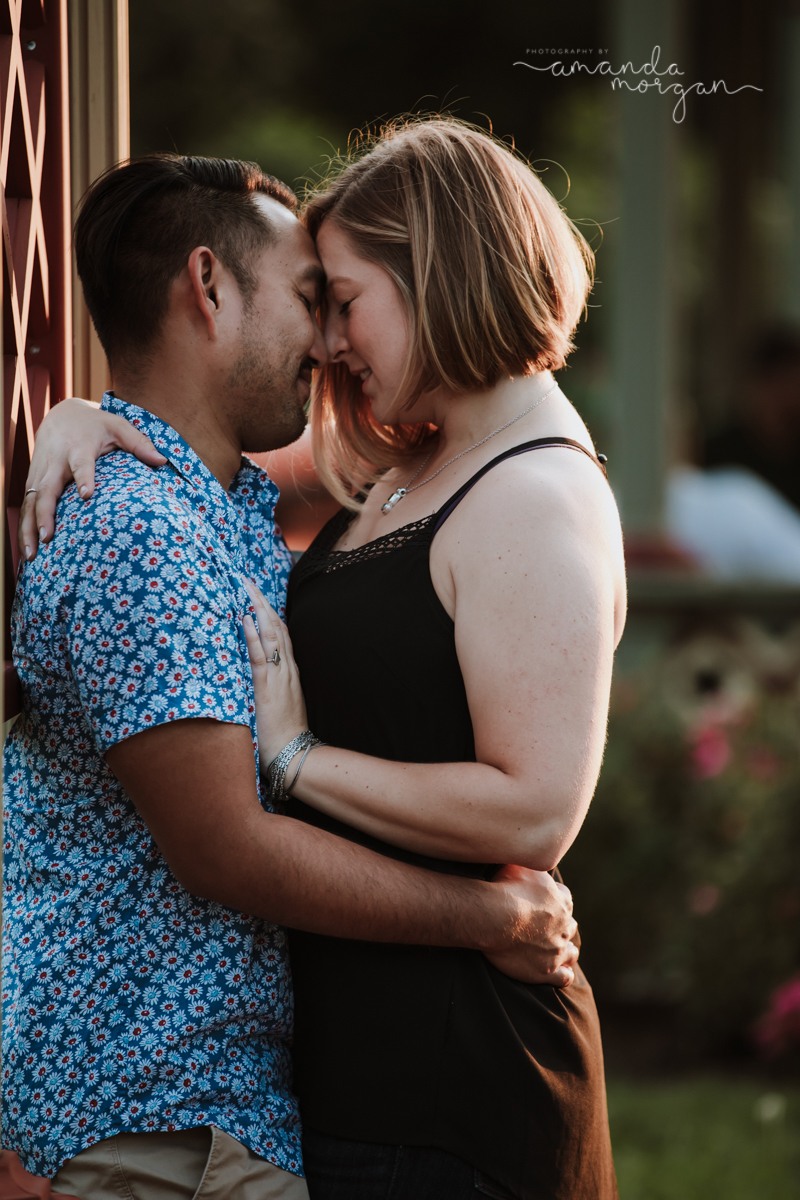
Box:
[106,718,577,985]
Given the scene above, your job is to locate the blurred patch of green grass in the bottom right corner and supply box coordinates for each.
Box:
[608,1079,800,1200]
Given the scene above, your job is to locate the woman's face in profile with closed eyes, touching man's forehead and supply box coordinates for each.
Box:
[317,218,410,422]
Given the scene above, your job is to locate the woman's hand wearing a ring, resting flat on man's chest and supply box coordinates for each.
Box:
[245,580,307,780]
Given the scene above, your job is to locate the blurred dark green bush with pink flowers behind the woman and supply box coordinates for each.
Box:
[563,622,800,1049]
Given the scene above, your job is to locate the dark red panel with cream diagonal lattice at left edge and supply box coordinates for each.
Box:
[0,0,72,716]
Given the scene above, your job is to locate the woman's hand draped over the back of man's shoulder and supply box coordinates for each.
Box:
[17,397,167,560]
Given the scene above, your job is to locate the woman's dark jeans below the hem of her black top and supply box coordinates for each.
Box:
[302,1127,515,1200]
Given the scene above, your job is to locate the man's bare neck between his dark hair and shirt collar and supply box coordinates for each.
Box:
[112,368,242,491]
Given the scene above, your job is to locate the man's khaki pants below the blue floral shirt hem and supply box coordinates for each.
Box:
[53,1126,308,1200]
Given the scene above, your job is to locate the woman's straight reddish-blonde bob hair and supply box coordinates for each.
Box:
[302,118,594,509]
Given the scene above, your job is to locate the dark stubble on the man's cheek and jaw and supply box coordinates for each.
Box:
[225,324,306,454]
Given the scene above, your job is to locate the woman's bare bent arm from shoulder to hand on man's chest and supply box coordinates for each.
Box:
[244,451,624,870]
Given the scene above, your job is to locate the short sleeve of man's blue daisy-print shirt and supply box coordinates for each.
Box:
[54,466,253,754]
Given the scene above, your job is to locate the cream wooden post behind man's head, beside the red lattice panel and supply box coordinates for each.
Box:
[70,0,131,400]
